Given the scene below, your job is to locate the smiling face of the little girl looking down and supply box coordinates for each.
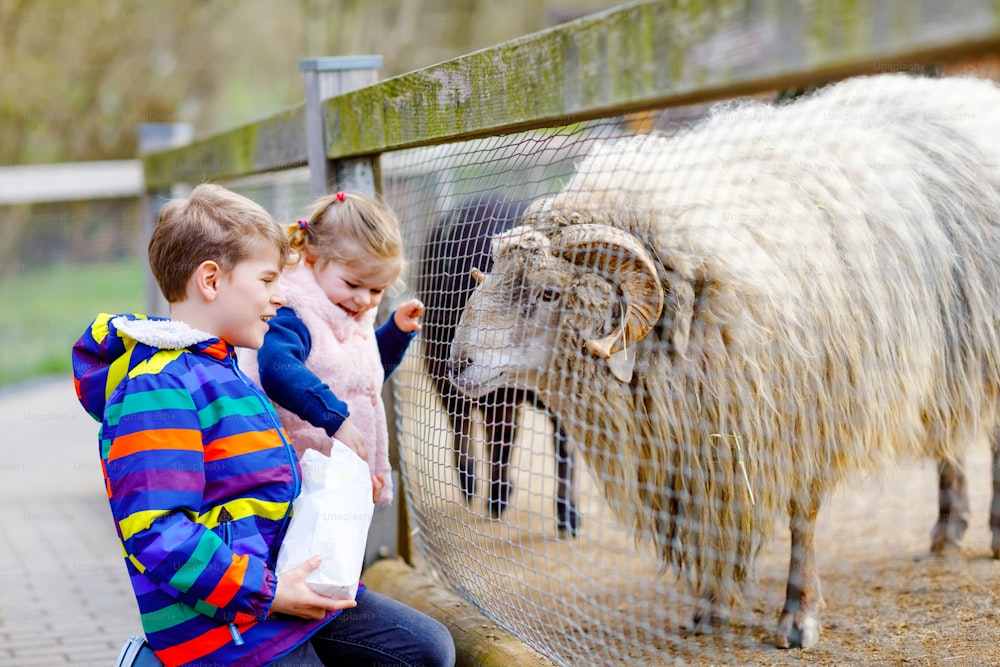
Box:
[303,243,400,319]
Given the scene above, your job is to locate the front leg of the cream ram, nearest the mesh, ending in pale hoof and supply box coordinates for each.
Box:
[774,497,824,648]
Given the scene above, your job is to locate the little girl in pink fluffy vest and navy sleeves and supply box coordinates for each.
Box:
[247,192,424,505]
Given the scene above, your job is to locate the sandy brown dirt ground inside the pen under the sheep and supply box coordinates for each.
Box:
[396,380,1000,667]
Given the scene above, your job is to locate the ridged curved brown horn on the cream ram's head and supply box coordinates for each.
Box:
[551,223,663,359]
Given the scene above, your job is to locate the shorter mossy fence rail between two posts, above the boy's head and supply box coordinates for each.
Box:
[142,104,306,189]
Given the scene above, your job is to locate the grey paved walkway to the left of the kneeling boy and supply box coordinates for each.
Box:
[0,376,139,667]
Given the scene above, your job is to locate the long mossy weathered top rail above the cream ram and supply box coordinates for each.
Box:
[324,0,1000,159]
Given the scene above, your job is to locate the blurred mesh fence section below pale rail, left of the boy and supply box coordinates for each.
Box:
[0,197,145,387]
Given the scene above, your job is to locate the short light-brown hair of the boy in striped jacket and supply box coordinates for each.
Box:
[149,183,289,303]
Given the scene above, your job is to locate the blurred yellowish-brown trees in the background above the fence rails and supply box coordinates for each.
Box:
[0,0,618,164]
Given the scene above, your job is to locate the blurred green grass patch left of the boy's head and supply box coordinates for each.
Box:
[0,259,146,387]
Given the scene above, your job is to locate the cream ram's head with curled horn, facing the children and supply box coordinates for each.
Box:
[449,224,663,401]
